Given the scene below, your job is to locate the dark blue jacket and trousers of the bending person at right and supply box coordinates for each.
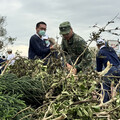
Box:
[96,46,120,102]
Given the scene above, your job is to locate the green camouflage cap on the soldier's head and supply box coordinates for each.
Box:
[59,21,71,35]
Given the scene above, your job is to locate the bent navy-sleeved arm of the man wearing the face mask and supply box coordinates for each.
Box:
[30,37,50,55]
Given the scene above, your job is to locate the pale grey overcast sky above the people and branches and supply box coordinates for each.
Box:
[0,0,120,54]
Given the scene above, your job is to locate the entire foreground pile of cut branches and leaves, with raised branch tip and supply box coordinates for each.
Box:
[0,19,120,120]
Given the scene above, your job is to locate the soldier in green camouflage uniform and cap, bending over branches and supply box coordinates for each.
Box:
[59,21,91,74]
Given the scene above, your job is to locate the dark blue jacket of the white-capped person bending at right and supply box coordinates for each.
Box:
[96,46,120,72]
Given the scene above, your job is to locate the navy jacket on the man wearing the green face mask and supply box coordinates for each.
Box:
[28,34,50,59]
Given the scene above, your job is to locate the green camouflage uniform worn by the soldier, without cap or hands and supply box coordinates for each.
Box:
[61,33,91,72]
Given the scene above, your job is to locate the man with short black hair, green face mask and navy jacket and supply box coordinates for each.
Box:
[28,22,53,59]
